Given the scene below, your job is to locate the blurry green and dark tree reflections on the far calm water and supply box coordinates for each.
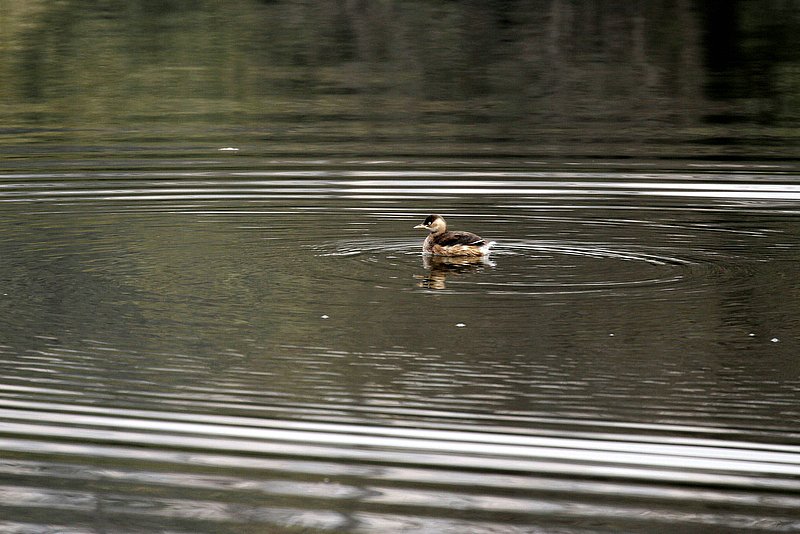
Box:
[0,0,800,155]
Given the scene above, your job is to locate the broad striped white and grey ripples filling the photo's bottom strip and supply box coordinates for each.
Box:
[0,402,800,532]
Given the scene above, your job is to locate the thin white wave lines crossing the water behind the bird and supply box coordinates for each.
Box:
[0,174,800,205]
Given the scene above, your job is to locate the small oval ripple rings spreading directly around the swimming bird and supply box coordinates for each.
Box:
[311,238,746,293]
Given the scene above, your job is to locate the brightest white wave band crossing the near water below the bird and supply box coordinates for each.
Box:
[0,408,800,486]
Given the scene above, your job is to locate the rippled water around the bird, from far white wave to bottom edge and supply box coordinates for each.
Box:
[0,156,800,532]
